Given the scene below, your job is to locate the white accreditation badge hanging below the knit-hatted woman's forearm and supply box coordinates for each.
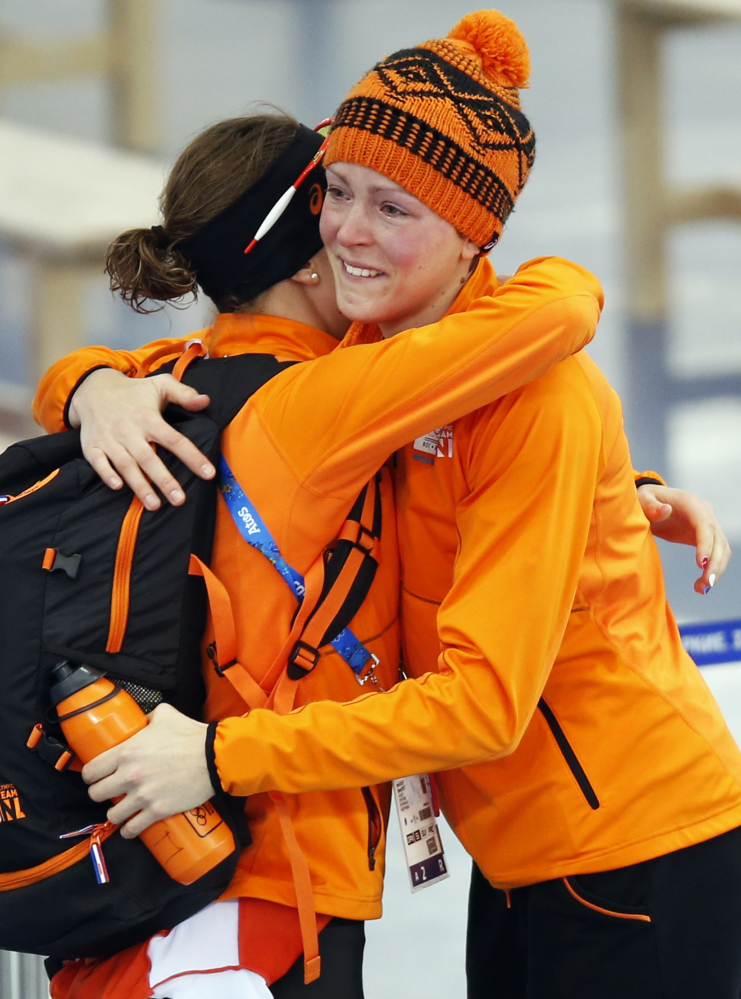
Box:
[394,774,450,892]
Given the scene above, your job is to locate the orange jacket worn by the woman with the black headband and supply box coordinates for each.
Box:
[34,258,602,919]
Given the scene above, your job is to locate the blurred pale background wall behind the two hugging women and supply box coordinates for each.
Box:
[0,0,741,999]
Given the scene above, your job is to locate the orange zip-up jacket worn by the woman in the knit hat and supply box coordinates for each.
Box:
[202,258,741,888]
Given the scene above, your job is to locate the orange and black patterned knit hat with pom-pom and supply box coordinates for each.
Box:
[324,10,535,251]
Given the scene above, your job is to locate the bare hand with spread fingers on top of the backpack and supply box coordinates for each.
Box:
[69,368,216,510]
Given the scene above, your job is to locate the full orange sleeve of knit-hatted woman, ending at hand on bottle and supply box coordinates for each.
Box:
[215,359,604,795]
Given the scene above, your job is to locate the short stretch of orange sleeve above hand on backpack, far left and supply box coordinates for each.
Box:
[33,338,199,433]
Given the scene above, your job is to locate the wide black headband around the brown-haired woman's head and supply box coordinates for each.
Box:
[177,125,327,302]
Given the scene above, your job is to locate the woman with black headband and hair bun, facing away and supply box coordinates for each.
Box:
[36,109,601,999]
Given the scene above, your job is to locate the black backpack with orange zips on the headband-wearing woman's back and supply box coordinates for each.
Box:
[0,354,372,959]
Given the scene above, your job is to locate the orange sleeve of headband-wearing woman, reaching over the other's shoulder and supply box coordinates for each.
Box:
[254,257,603,495]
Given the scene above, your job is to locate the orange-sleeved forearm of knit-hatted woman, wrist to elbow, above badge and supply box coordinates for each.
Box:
[214,664,512,795]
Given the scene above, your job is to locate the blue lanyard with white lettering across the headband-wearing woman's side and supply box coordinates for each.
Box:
[218,454,377,682]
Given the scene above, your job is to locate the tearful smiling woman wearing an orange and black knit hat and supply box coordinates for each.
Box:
[33,11,741,999]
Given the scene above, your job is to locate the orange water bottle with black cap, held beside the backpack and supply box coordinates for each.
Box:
[49,660,236,885]
